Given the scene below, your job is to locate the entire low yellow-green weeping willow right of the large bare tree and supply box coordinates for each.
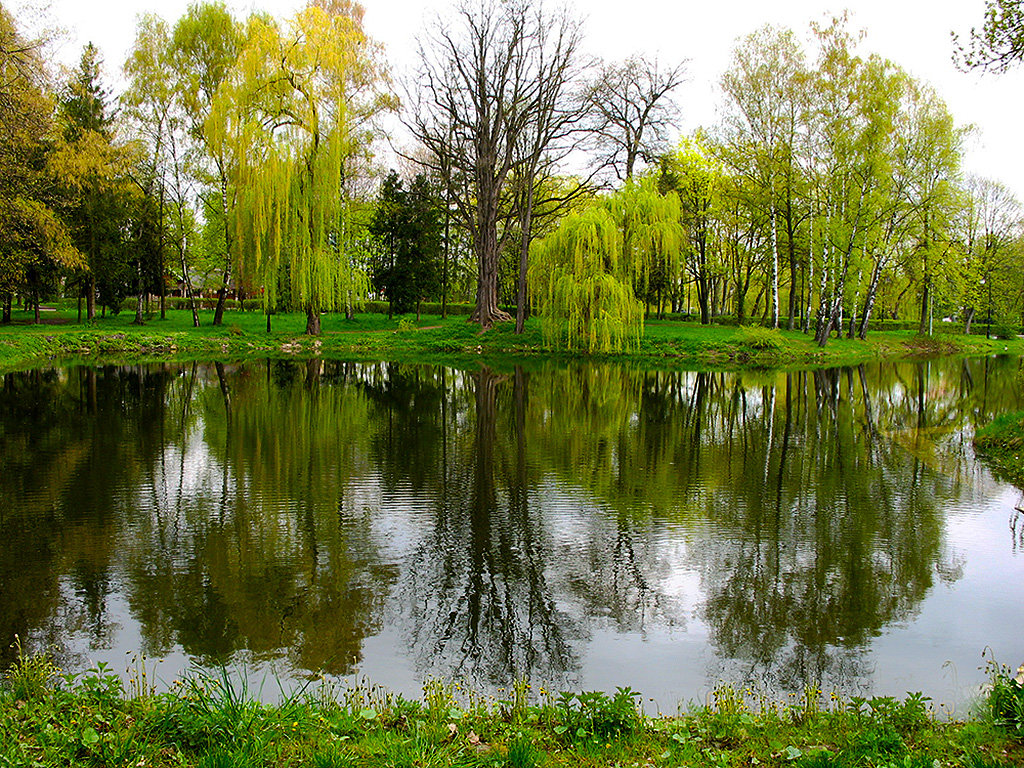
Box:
[529,179,682,352]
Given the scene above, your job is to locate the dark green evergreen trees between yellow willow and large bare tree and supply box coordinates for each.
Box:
[370,171,442,314]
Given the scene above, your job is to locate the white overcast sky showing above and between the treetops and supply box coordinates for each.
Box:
[22,0,1024,201]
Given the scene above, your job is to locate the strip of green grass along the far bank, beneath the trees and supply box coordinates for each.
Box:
[0,309,1024,371]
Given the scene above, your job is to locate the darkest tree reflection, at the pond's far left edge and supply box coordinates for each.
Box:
[0,367,172,668]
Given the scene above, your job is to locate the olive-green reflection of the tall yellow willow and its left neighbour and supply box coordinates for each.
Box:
[117,361,393,673]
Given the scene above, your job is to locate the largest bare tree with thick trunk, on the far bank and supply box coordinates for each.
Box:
[406,0,581,328]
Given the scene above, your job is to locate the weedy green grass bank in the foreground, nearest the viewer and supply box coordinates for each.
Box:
[0,656,1024,768]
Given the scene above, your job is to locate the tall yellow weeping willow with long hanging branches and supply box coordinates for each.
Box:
[212,0,393,335]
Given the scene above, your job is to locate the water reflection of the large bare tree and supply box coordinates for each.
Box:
[395,368,578,685]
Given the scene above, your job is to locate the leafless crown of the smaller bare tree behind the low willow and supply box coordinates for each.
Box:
[589,55,686,181]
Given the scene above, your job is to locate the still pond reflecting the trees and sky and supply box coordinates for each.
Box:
[0,357,1024,712]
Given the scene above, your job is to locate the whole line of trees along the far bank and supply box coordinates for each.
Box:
[0,0,1024,349]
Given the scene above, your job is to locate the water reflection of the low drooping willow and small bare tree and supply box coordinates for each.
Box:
[530,367,730,631]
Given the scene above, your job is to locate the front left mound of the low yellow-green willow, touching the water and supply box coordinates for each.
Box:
[529,207,643,351]
